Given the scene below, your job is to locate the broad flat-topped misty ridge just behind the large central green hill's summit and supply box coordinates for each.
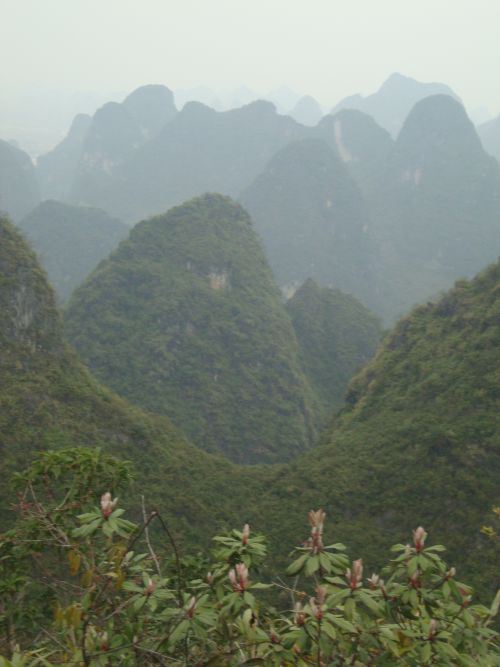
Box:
[66,100,307,222]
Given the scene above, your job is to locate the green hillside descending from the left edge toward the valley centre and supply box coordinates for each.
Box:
[0,219,258,545]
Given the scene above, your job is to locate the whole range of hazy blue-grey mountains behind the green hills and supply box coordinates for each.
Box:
[0,75,494,322]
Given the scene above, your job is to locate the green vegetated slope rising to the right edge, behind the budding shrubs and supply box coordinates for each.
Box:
[262,263,500,591]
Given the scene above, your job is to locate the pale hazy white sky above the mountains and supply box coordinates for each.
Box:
[0,0,500,114]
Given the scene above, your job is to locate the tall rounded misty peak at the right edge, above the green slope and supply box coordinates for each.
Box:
[370,95,500,314]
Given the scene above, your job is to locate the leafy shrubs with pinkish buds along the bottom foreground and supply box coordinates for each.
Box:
[0,450,500,667]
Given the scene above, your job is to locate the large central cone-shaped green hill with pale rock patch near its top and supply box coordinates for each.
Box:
[66,195,318,462]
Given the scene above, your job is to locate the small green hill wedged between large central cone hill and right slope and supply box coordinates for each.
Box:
[286,279,381,418]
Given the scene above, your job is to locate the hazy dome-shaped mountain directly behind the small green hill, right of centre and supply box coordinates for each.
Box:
[240,139,377,305]
